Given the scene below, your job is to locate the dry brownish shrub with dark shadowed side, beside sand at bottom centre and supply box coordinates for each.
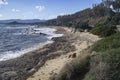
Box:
[51,53,90,80]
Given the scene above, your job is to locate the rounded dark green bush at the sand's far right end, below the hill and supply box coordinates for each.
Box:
[91,24,116,37]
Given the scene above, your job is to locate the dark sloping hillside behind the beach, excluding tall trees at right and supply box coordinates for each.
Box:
[47,7,114,26]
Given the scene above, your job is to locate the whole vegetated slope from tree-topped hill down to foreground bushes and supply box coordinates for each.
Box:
[48,0,120,80]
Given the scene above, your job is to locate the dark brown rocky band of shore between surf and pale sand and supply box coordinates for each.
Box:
[0,28,75,80]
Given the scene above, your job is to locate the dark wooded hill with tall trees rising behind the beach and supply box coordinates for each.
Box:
[45,0,120,31]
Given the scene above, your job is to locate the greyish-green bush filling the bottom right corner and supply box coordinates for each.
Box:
[84,48,120,80]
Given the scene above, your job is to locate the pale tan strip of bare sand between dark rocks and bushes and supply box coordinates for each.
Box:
[27,28,100,80]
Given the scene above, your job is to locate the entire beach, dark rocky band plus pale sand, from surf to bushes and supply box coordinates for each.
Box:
[0,27,100,80]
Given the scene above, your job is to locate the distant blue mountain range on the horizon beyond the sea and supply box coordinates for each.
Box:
[0,19,46,23]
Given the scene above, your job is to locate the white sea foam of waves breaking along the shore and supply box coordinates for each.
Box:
[0,26,63,61]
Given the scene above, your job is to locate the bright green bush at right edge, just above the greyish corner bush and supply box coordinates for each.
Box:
[92,32,120,52]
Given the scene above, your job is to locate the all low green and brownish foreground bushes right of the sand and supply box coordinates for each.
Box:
[52,32,120,80]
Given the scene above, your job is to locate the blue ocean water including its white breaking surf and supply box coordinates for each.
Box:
[0,25,62,61]
